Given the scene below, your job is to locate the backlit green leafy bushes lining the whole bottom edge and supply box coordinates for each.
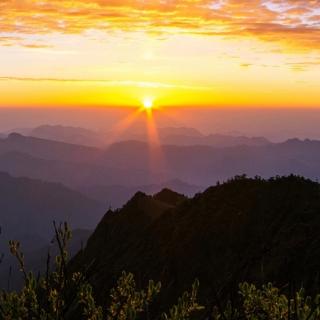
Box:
[0,223,320,320]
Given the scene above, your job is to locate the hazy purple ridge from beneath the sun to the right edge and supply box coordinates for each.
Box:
[99,140,320,186]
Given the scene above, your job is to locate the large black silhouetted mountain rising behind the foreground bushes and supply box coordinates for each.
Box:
[71,176,320,307]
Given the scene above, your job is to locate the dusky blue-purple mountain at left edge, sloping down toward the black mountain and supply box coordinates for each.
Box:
[0,173,105,244]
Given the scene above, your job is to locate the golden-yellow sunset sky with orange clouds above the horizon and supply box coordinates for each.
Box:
[0,0,320,108]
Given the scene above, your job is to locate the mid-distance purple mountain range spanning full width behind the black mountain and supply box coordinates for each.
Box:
[0,133,320,200]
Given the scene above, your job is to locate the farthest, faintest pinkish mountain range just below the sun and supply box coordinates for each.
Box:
[4,125,270,148]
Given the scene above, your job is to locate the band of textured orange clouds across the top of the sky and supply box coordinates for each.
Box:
[0,0,320,49]
